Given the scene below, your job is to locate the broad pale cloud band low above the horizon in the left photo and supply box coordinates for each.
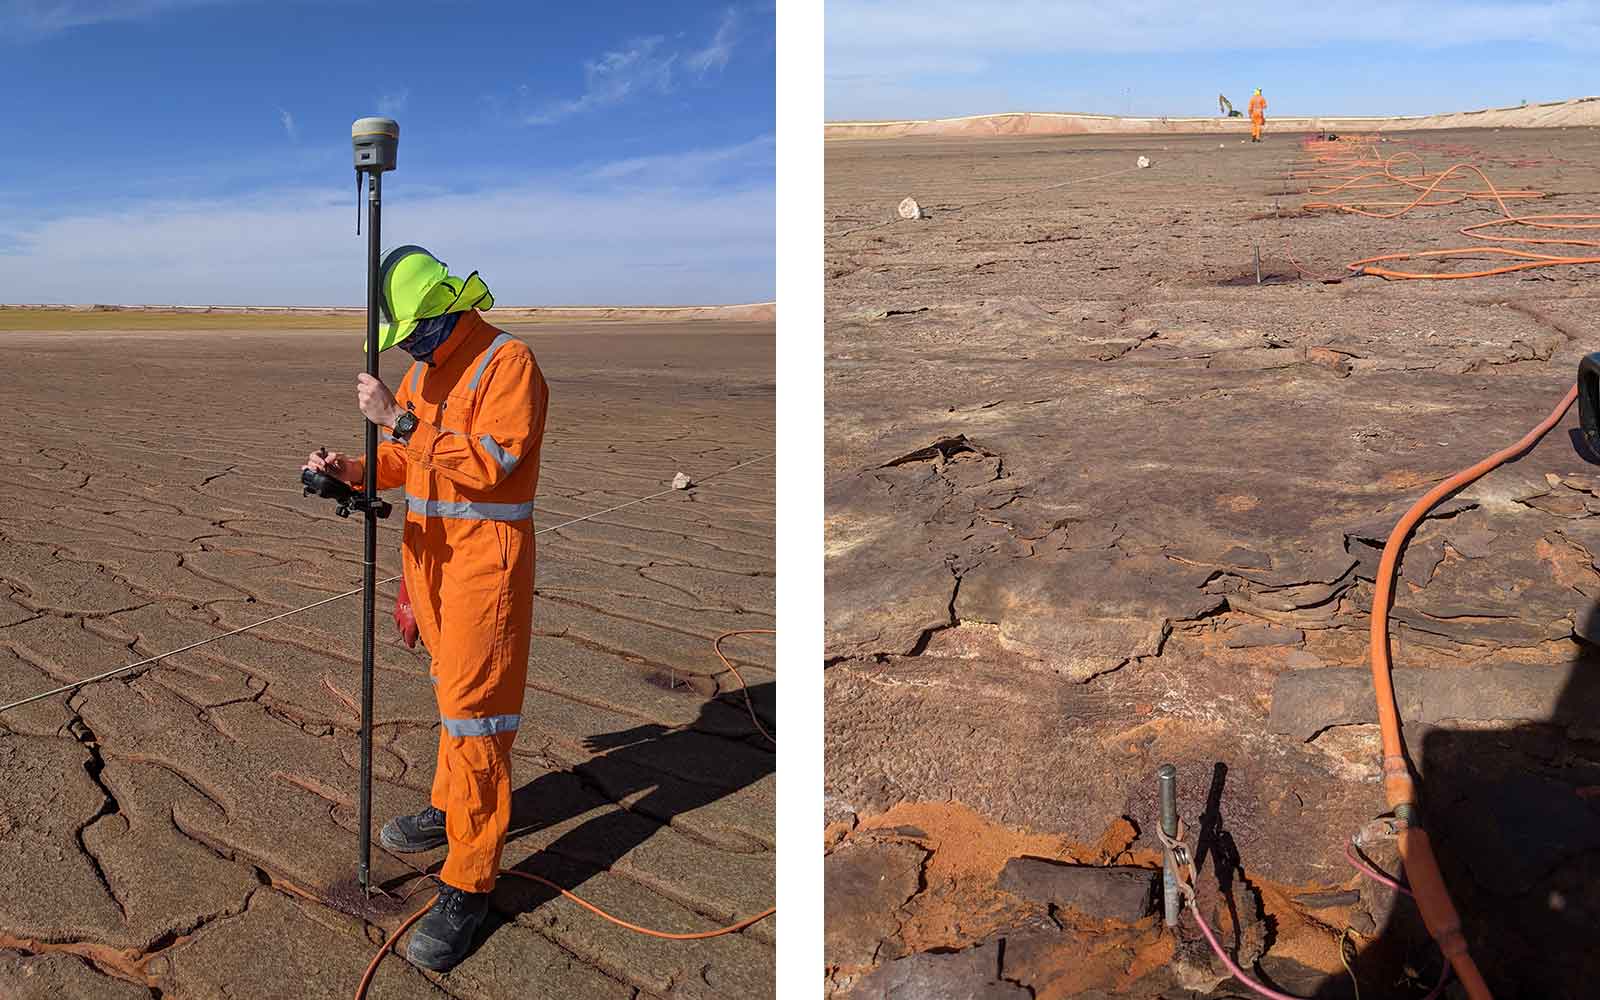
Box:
[0,174,776,306]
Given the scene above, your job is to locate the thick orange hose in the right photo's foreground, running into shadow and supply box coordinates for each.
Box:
[1371,386,1578,1000]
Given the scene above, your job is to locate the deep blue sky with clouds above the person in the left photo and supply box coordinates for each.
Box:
[0,0,776,304]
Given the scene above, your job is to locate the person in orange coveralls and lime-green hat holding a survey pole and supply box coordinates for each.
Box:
[306,246,549,971]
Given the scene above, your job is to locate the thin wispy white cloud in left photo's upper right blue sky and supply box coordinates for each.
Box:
[531,8,738,125]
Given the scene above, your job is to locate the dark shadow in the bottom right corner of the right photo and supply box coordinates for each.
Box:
[1315,630,1600,1000]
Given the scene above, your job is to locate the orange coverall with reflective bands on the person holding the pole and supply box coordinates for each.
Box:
[353,310,549,893]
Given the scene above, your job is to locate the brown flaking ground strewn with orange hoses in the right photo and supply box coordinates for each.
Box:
[826,123,1600,998]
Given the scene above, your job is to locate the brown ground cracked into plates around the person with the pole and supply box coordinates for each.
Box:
[0,312,776,1000]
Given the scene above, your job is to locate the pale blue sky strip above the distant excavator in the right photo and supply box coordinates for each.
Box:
[826,0,1600,120]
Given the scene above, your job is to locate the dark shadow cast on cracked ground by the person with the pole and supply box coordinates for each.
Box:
[457,682,778,950]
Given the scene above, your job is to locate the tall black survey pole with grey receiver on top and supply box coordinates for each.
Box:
[349,118,400,893]
